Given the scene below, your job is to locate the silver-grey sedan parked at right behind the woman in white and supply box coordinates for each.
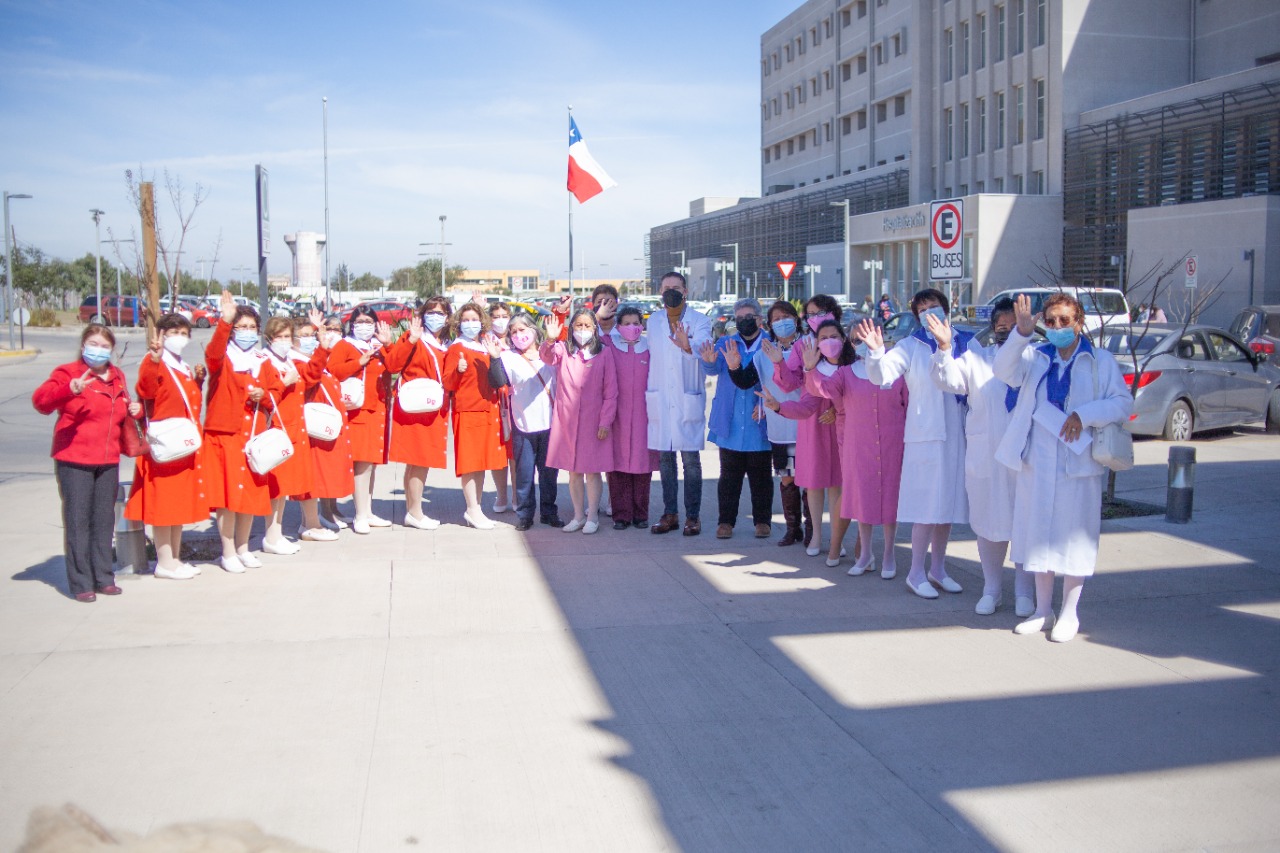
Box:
[1098,323,1280,442]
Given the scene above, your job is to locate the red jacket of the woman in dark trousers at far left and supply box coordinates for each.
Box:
[31,360,133,465]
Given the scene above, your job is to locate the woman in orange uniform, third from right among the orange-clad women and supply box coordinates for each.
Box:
[329,306,392,534]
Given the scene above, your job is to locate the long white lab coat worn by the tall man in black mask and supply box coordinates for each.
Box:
[644,304,712,451]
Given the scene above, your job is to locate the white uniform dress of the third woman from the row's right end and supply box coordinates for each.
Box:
[865,338,969,524]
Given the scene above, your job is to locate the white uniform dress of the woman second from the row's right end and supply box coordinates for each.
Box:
[933,343,1014,542]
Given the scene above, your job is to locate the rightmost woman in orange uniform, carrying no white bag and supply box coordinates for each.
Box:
[444,302,507,530]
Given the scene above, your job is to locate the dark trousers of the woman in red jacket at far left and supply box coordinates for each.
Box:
[54,462,120,596]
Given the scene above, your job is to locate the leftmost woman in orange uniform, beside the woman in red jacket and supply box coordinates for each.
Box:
[124,314,209,580]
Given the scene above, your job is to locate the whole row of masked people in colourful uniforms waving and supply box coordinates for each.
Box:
[35,273,1133,642]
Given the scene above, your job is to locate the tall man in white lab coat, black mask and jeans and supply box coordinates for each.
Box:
[644,273,712,537]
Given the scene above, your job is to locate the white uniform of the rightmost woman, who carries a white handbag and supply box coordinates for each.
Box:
[993,329,1133,576]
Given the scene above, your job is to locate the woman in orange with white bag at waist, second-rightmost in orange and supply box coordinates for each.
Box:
[385,296,449,530]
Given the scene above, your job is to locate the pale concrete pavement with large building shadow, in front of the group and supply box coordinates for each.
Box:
[0,336,1280,852]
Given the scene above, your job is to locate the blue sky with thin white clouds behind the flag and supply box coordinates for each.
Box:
[0,0,796,280]
